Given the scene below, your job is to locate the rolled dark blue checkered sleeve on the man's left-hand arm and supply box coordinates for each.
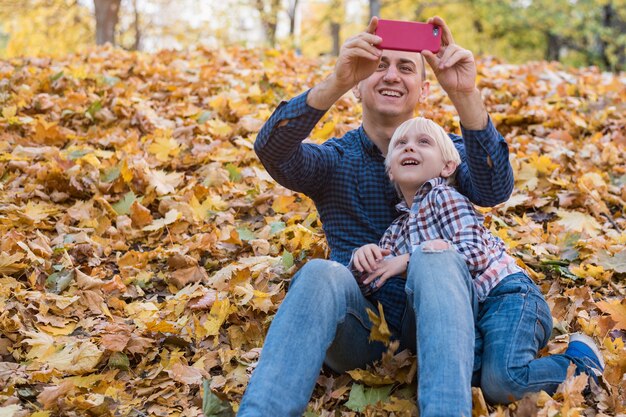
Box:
[254,91,339,194]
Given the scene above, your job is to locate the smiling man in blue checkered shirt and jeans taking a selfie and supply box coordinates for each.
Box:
[239,17,600,417]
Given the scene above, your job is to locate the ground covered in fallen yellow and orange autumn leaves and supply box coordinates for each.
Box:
[0,49,626,416]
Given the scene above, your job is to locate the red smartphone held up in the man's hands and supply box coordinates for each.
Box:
[375,19,441,53]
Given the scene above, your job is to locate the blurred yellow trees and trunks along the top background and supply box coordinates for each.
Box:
[0,0,626,71]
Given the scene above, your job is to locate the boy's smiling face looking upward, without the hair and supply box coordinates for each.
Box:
[389,132,456,193]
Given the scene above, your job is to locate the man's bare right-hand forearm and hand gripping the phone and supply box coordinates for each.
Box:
[422,16,489,130]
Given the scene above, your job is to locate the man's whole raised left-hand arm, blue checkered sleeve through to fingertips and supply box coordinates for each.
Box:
[254,18,381,195]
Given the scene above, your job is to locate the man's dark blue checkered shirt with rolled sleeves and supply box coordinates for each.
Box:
[254,91,513,327]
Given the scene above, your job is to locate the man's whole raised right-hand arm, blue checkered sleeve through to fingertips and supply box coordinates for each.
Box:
[422,17,513,207]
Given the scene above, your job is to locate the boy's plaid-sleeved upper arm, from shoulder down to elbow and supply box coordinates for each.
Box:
[431,188,490,274]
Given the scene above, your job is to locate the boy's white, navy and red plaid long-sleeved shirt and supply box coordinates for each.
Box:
[379,177,524,301]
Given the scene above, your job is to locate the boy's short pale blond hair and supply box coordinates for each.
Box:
[385,117,461,182]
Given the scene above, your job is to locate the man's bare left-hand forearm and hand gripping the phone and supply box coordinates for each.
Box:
[307,16,382,110]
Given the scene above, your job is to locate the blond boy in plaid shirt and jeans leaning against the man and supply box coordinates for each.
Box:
[351,118,604,402]
